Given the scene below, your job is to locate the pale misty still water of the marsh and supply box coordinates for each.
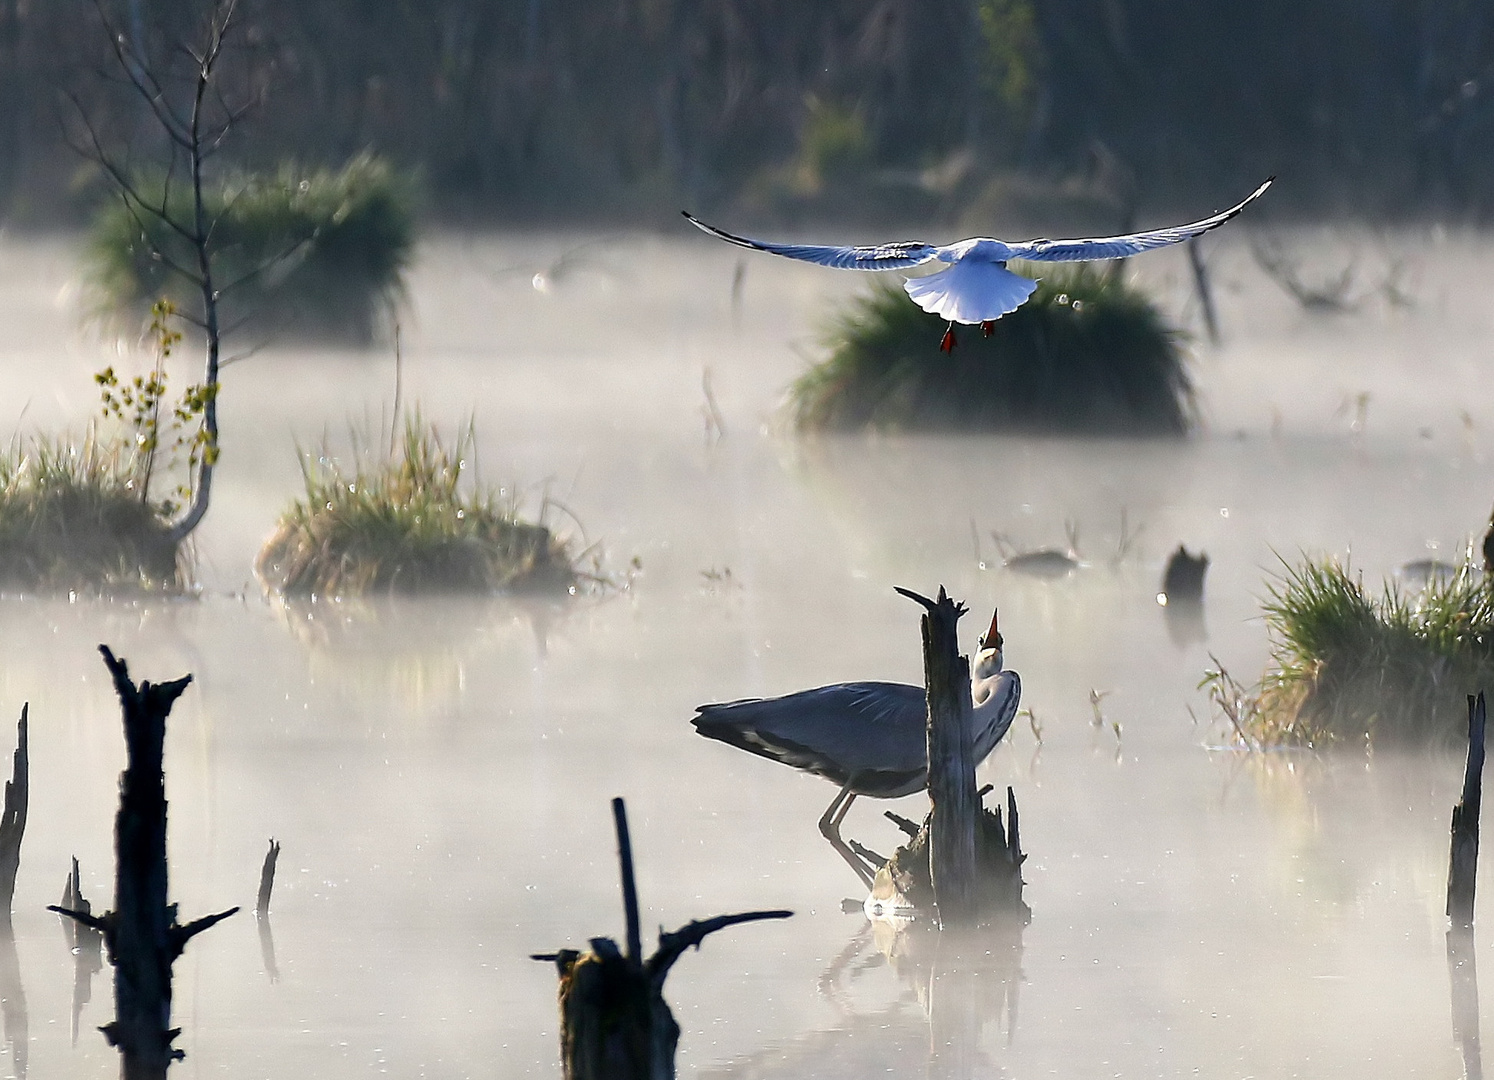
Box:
[0,224,1494,1080]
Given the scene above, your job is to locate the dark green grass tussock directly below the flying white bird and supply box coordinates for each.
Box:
[789,264,1194,435]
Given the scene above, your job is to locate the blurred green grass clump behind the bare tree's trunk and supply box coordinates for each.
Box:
[90,154,415,341]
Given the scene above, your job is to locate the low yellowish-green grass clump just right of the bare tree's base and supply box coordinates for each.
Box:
[255,420,581,596]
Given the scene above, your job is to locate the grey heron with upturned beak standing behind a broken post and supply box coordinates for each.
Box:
[690,614,1022,881]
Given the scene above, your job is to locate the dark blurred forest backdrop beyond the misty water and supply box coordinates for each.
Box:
[0,0,1494,226]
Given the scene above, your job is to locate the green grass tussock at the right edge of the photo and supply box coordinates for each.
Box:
[1206,559,1494,745]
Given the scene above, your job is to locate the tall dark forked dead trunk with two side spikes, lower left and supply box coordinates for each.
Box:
[51,645,239,1080]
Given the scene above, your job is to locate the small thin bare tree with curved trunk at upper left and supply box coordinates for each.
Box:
[70,0,256,544]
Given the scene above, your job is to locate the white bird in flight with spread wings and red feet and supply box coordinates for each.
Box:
[681,176,1276,353]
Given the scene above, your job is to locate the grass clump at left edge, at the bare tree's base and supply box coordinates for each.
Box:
[0,435,182,593]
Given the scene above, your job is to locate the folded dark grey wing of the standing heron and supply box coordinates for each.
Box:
[692,683,928,783]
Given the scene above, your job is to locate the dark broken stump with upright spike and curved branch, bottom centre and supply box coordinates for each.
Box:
[533,799,792,1080]
